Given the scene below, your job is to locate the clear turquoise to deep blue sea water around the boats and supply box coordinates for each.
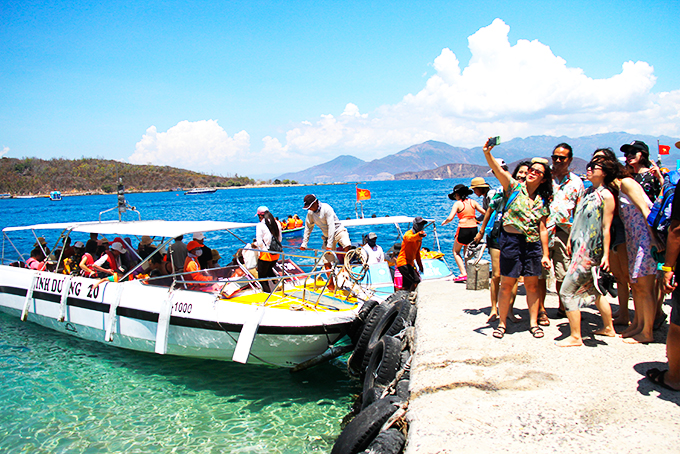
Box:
[0,180,493,453]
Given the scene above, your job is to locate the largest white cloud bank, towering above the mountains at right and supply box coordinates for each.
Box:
[263,19,680,168]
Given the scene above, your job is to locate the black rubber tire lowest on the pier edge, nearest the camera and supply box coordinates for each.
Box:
[331,396,400,454]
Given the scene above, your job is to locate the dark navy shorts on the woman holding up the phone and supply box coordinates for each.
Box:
[499,230,543,279]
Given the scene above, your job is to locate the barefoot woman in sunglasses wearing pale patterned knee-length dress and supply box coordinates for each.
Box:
[555,158,618,347]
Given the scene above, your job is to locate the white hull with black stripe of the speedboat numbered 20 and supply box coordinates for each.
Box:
[0,265,358,367]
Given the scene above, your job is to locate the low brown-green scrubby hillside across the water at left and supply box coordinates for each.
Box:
[0,157,255,195]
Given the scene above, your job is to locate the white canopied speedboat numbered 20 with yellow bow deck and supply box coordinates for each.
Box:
[0,221,362,367]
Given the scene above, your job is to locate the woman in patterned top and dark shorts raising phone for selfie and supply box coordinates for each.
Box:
[483,139,552,339]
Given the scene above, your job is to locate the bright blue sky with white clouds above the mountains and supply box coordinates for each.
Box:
[0,0,680,178]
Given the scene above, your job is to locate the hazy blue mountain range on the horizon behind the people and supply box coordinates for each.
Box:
[278,132,680,183]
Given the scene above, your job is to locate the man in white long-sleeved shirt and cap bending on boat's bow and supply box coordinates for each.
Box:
[300,194,352,291]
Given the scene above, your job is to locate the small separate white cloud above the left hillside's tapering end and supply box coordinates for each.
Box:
[129,120,250,173]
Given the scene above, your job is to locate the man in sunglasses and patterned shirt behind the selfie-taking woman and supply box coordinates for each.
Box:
[538,143,584,326]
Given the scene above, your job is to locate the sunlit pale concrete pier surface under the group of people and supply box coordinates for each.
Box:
[406,281,680,454]
